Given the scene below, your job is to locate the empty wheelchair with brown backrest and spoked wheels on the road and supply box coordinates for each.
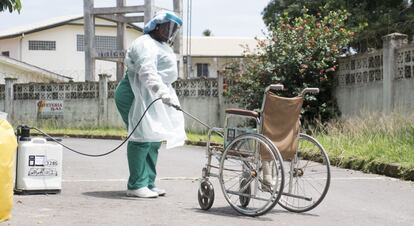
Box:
[198,84,331,216]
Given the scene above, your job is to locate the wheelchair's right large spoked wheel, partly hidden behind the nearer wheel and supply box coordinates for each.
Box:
[279,134,331,213]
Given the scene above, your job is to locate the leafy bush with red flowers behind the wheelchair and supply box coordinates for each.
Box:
[226,9,353,125]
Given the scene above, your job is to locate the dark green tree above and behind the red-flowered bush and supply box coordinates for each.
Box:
[263,0,414,51]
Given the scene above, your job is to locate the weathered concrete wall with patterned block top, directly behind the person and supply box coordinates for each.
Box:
[0,76,224,131]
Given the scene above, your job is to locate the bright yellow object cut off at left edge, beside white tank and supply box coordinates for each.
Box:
[0,117,17,222]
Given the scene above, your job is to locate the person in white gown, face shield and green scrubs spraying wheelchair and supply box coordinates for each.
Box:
[115,11,186,198]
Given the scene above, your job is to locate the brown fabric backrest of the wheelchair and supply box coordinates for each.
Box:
[261,91,303,160]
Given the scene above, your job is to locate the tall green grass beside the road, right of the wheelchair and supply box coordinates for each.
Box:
[316,114,414,169]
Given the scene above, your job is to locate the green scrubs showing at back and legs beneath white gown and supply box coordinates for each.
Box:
[115,75,161,190]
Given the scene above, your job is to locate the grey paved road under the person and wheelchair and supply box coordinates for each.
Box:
[5,139,414,226]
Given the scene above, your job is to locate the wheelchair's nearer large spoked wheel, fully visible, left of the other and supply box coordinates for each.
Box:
[219,134,284,216]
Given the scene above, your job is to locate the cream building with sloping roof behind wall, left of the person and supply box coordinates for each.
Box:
[0,15,142,81]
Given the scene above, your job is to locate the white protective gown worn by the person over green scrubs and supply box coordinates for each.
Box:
[126,34,186,149]
